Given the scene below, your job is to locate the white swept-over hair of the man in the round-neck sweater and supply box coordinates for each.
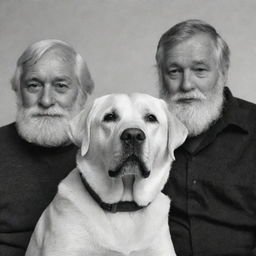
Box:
[11,39,94,95]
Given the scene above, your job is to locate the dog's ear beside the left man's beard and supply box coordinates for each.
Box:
[68,101,93,156]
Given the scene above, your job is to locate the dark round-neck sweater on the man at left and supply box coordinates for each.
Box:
[0,123,77,256]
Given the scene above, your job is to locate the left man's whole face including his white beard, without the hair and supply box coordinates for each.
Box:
[17,50,86,146]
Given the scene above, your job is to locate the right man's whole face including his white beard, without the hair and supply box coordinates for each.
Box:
[162,34,224,136]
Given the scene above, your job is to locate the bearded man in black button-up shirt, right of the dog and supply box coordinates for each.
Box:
[156,20,256,256]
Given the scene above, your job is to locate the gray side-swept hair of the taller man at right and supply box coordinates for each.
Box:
[156,19,230,92]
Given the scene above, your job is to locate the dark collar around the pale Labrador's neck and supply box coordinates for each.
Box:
[79,172,145,213]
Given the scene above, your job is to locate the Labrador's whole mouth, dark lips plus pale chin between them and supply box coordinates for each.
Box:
[108,154,150,178]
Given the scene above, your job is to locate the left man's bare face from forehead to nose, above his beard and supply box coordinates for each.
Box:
[20,50,82,109]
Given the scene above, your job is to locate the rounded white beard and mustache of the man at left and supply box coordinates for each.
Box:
[16,95,84,147]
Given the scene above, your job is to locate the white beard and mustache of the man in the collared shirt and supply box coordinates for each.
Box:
[167,79,224,137]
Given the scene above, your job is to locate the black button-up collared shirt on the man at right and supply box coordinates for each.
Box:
[164,88,256,256]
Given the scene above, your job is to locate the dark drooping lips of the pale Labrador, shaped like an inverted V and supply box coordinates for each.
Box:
[108,154,150,178]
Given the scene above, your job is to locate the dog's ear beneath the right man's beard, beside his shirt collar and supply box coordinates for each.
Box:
[167,106,188,160]
